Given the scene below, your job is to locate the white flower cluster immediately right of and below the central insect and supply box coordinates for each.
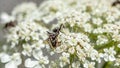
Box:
[49,31,102,68]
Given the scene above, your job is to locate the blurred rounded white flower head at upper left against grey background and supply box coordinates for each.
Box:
[12,2,37,21]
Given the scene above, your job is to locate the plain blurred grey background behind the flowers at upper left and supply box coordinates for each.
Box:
[0,0,43,42]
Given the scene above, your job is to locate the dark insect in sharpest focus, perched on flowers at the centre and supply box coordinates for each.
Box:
[47,24,63,49]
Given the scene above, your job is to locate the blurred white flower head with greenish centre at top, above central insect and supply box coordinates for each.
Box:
[39,0,66,24]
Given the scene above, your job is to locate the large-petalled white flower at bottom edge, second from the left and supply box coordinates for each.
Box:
[25,50,49,68]
